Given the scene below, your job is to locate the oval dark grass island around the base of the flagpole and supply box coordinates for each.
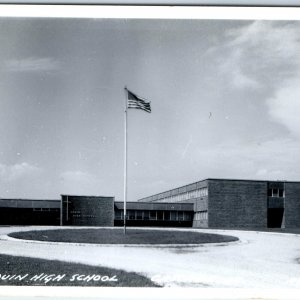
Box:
[9,228,238,245]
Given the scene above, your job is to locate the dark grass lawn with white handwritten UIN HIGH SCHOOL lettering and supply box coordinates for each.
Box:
[0,254,159,287]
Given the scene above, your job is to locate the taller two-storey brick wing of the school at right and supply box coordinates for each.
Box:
[139,179,300,228]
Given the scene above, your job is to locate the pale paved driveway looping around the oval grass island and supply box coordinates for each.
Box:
[0,227,300,289]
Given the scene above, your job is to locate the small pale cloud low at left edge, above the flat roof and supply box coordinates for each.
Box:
[0,162,41,182]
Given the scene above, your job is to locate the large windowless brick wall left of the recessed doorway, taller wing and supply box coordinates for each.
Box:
[208,179,267,228]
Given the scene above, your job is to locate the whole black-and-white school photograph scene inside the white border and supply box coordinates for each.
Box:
[0,4,300,299]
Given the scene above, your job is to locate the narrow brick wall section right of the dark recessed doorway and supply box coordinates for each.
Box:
[285,182,300,228]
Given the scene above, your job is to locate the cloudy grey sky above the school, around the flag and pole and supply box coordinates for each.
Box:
[0,17,300,201]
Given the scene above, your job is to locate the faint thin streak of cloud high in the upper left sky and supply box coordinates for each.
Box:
[6,57,60,72]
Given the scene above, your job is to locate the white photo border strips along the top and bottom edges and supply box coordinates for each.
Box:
[0,4,300,300]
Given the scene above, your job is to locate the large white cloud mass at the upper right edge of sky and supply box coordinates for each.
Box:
[223,21,300,138]
